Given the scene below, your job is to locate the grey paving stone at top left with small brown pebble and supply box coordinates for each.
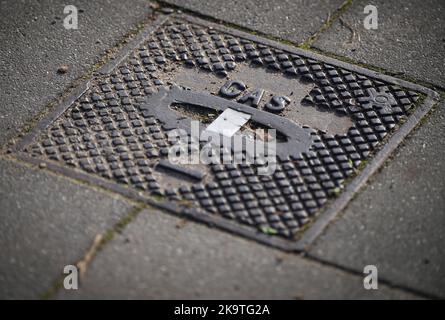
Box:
[0,0,150,145]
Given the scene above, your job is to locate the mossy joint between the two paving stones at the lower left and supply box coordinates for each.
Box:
[39,205,144,300]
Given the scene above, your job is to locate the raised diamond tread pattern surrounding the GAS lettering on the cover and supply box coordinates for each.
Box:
[21,17,419,239]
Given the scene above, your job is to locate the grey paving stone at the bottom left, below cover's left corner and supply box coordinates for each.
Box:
[0,160,131,299]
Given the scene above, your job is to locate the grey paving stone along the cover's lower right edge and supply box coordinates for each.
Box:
[311,103,445,297]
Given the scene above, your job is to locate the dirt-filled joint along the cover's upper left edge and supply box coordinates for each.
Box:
[0,10,162,155]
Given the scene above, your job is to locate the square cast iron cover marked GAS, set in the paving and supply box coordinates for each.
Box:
[13,15,437,251]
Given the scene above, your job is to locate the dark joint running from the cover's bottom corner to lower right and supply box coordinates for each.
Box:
[304,253,443,300]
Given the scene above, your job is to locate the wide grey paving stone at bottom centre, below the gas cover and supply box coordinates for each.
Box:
[58,211,415,299]
